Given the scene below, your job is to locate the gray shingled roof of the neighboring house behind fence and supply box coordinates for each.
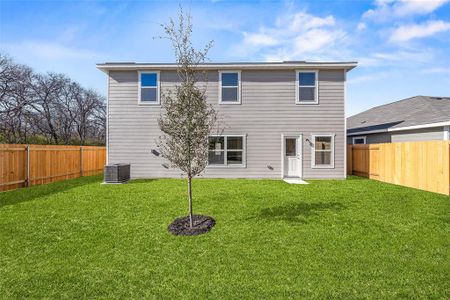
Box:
[347,96,450,135]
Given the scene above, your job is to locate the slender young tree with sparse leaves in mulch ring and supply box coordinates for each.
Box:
[158,9,217,228]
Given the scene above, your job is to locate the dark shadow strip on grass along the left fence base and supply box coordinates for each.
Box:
[0,175,101,208]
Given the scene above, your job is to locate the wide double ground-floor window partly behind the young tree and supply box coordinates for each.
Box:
[208,135,245,166]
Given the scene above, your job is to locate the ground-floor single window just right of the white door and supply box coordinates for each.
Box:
[311,135,334,168]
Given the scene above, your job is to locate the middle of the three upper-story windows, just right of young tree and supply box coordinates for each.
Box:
[219,71,241,104]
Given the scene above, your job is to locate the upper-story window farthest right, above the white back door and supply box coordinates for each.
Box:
[296,71,319,104]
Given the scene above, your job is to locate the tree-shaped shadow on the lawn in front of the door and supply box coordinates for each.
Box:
[256,202,345,223]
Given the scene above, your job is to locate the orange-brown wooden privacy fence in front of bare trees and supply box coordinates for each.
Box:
[0,144,106,191]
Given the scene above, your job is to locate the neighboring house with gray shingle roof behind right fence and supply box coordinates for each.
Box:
[347,96,450,144]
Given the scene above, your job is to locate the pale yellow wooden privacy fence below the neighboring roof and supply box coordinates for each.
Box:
[347,141,450,195]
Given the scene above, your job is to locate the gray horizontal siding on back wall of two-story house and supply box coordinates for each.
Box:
[108,70,345,178]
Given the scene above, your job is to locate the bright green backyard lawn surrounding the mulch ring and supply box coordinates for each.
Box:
[0,176,450,299]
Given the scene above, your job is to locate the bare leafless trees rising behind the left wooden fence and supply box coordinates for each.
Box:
[0,53,106,145]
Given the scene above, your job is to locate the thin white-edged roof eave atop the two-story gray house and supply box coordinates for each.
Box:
[97,61,357,72]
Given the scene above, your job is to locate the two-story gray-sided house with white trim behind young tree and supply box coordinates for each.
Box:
[97,62,356,178]
